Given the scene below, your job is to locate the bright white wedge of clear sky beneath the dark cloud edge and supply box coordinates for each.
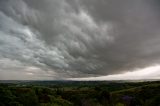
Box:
[68,65,160,81]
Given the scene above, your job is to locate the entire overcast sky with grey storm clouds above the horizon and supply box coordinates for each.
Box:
[0,0,160,80]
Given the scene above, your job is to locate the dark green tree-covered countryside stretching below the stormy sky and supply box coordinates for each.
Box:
[0,81,160,106]
